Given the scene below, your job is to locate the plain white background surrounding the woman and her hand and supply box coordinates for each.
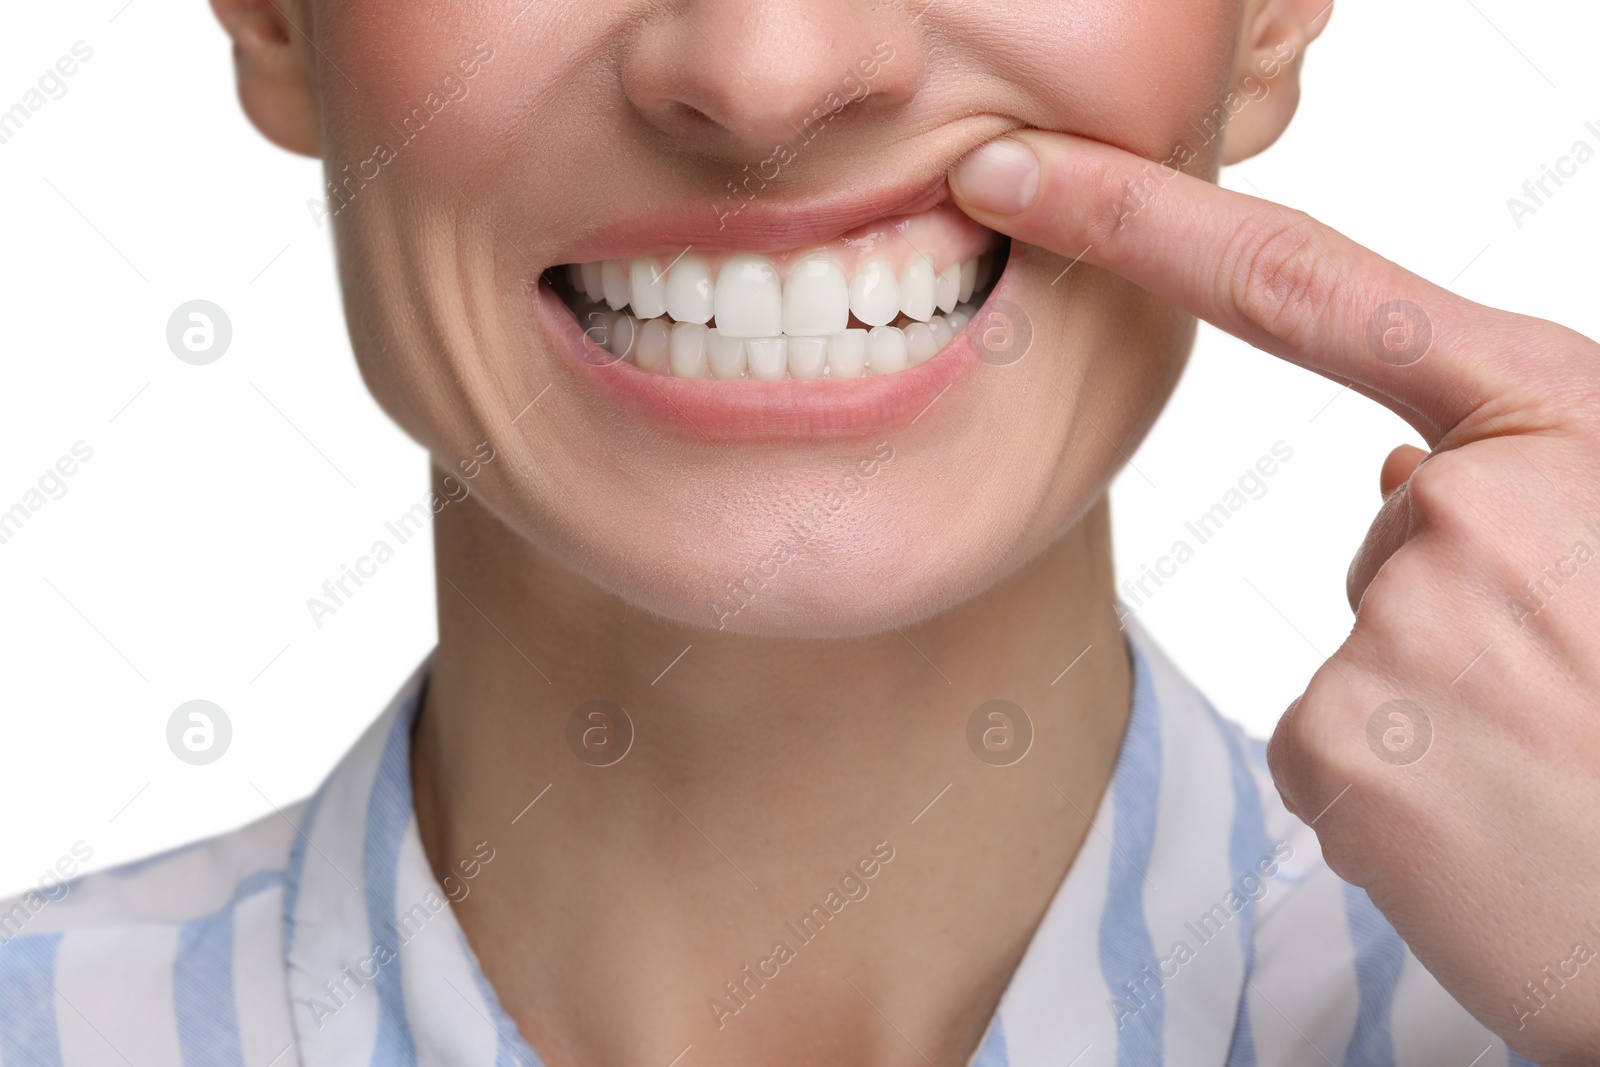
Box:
[0,0,1600,891]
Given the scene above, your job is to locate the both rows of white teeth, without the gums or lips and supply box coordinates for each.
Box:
[566,253,992,381]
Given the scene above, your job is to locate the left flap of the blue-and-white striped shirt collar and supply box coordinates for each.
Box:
[283,657,539,1067]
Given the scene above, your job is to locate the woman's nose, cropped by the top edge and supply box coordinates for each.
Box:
[622,0,922,157]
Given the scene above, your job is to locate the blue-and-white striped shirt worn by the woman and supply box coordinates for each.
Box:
[0,625,1528,1067]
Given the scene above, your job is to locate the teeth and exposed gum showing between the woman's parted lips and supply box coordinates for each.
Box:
[547,203,1010,382]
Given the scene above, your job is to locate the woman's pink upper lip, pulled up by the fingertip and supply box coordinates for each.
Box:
[565,170,950,262]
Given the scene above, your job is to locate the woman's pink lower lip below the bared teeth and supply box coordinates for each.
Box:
[533,274,1005,445]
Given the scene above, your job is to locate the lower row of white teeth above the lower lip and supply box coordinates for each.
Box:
[563,301,981,381]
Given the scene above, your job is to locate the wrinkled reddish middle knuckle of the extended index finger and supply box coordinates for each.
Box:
[1221,210,1342,346]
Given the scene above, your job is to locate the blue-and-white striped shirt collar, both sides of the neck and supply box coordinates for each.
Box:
[283,621,1272,1067]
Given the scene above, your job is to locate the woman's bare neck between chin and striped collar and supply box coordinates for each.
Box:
[413,473,1130,1064]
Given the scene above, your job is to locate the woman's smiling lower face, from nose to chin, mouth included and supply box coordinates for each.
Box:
[307,0,1245,637]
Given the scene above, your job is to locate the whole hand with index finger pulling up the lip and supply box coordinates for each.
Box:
[950,131,1600,1067]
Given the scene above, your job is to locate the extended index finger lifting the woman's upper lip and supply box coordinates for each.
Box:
[950,130,1506,445]
